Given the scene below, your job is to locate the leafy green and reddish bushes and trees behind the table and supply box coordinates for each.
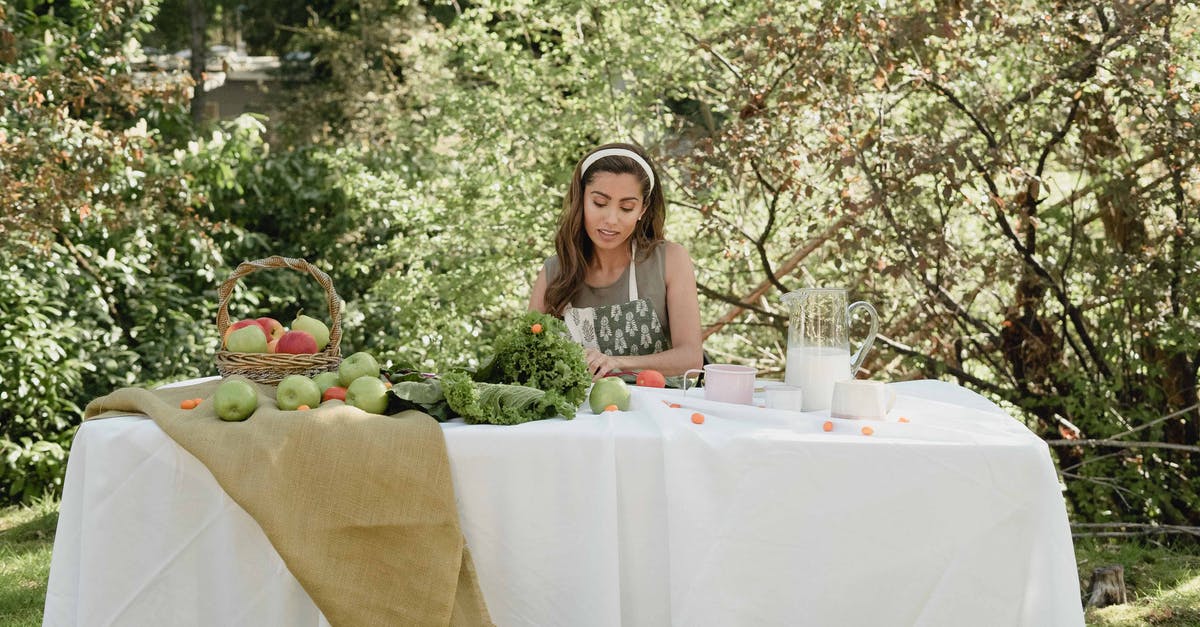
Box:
[0,0,1200,526]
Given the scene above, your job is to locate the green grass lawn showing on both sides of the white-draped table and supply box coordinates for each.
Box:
[0,502,1200,627]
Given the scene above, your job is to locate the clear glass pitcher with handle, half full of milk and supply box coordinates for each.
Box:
[784,287,880,412]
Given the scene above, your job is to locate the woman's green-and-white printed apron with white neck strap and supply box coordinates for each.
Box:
[563,244,671,356]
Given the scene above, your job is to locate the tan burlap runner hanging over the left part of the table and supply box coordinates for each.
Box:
[84,372,492,627]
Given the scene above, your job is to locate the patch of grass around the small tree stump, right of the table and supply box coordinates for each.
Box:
[1075,538,1200,627]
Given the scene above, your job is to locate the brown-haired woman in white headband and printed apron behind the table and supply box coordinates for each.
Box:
[529,144,703,378]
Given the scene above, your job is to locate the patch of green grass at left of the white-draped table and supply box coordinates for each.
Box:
[0,502,59,627]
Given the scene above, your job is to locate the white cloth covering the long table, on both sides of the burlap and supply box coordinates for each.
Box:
[44,381,1084,627]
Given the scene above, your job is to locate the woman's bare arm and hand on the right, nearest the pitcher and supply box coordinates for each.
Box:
[587,241,704,378]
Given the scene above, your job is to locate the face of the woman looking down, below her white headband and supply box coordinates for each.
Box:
[583,172,646,250]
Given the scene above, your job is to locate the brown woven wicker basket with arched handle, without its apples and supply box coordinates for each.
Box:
[216,256,342,384]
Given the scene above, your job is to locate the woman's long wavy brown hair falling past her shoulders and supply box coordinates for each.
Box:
[546,143,666,317]
